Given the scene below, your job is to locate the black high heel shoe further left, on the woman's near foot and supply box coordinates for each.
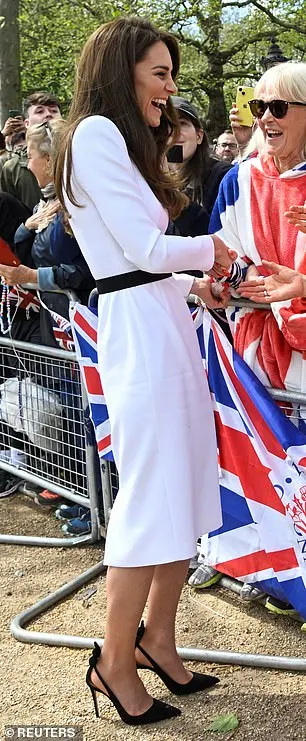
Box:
[86,642,181,726]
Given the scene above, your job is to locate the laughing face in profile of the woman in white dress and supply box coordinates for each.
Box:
[134,41,176,127]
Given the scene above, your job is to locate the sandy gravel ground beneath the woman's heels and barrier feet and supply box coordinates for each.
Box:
[0,494,306,741]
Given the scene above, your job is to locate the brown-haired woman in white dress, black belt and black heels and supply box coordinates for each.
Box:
[56,18,233,725]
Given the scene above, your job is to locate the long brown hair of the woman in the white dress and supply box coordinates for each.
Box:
[55,17,188,218]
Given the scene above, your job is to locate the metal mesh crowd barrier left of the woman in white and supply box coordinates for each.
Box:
[0,285,105,547]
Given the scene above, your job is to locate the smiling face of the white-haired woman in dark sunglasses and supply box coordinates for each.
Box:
[256,86,306,172]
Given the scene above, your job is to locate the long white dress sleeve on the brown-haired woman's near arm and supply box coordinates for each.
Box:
[68,116,214,273]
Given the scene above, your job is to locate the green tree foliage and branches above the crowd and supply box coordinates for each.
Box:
[13,0,306,135]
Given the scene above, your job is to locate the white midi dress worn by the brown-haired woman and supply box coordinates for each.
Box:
[66,116,221,567]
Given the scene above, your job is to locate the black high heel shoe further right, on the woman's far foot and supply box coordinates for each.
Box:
[135,621,220,695]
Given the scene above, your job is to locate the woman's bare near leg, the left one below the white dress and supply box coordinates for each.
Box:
[91,566,154,715]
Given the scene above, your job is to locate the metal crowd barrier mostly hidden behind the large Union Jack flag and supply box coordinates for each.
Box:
[7,300,306,672]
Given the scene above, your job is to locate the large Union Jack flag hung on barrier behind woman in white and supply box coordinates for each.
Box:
[71,304,306,618]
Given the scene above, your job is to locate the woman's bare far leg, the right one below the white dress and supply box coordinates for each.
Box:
[136,560,192,684]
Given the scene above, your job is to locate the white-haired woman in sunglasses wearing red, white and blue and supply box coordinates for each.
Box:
[210,62,306,391]
